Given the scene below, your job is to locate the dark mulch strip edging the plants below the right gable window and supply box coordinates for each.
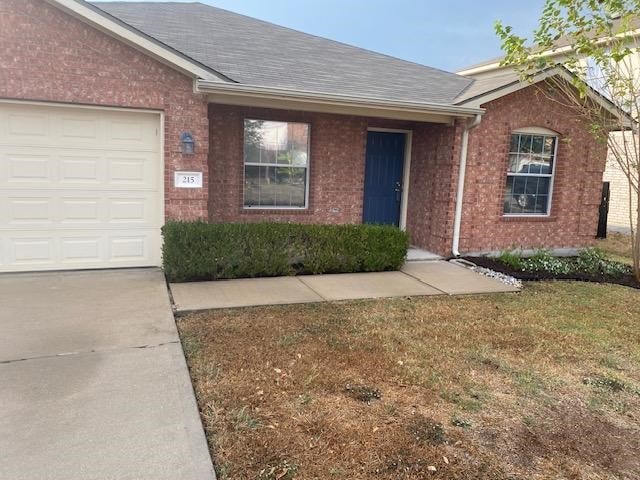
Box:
[463,257,640,289]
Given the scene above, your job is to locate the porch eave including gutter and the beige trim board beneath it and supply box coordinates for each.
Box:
[196,80,484,123]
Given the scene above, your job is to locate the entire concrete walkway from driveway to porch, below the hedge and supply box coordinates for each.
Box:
[170,261,518,312]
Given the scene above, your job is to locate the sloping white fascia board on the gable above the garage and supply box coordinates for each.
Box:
[45,0,226,82]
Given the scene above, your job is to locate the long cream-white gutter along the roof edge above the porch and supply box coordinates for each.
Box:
[196,80,484,117]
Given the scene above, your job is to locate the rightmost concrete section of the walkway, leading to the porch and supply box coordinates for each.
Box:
[402,262,518,295]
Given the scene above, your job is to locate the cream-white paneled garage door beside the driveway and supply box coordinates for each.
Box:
[0,102,163,271]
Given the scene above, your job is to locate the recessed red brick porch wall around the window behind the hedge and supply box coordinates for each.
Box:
[209,104,446,231]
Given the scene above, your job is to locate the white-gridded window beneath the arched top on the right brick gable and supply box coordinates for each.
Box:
[504,133,558,215]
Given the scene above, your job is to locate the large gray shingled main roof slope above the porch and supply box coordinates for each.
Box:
[93,2,473,105]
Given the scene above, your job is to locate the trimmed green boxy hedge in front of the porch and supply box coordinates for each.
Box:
[162,222,409,282]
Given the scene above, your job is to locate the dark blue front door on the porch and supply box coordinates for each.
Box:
[362,132,405,225]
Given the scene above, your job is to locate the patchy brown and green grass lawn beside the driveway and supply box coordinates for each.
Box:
[178,282,640,480]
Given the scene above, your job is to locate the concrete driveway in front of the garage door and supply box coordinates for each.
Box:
[0,269,215,480]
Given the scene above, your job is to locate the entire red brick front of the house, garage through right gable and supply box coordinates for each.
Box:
[0,0,606,270]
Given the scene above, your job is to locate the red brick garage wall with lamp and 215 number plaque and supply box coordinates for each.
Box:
[0,0,208,219]
